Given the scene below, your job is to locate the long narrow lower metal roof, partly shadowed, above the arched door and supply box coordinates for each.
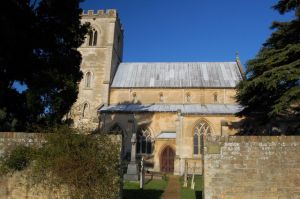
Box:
[99,104,241,115]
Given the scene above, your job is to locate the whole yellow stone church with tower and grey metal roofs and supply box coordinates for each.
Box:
[68,9,243,175]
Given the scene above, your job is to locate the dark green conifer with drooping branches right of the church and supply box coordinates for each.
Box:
[237,0,300,134]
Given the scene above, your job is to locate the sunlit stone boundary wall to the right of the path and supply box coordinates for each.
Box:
[204,136,300,199]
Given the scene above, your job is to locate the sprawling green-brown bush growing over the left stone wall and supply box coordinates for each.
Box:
[2,128,121,199]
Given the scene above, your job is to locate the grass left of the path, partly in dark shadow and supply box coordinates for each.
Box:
[123,180,168,199]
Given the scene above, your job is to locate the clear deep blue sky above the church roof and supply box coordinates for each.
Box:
[81,0,292,67]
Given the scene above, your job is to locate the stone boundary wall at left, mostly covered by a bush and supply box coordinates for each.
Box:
[0,132,122,199]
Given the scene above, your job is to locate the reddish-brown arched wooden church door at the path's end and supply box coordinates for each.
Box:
[160,146,175,173]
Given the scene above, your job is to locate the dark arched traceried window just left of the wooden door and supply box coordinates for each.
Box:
[136,129,152,154]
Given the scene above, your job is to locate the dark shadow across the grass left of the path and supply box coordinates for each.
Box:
[123,189,163,199]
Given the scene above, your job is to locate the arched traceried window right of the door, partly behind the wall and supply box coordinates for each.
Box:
[193,121,211,155]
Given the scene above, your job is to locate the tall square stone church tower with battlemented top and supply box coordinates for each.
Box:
[68,10,123,130]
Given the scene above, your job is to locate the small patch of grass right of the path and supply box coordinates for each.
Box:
[180,176,203,199]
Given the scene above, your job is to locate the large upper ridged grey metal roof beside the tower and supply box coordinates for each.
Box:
[111,62,242,88]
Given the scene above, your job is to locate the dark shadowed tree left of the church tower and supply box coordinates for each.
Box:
[0,0,89,131]
